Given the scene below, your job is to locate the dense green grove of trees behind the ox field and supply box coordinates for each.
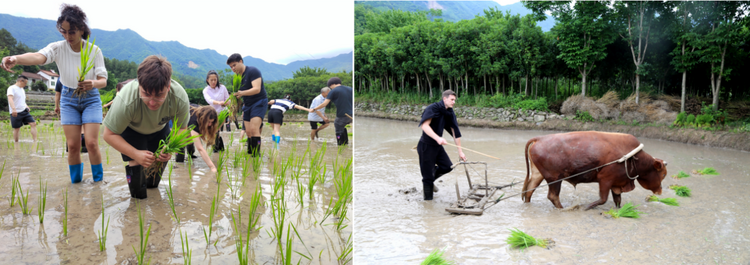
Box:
[354,1,750,108]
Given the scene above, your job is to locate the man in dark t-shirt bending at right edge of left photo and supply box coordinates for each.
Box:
[310,77,354,145]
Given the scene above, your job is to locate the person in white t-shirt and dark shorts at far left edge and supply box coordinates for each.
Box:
[8,75,36,142]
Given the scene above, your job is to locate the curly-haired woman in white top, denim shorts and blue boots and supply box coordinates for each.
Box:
[2,4,107,183]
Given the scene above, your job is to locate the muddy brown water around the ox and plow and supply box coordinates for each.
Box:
[354,118,750,264]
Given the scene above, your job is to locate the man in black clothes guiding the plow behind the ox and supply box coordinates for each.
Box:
[417,90,466,201]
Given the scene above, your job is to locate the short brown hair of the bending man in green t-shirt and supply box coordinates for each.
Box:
[137,55,172,95]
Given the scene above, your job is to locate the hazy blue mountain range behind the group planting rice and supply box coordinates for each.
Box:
[0,14,354,81]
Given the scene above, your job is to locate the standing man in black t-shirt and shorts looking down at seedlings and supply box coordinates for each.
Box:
[227,53,268,156]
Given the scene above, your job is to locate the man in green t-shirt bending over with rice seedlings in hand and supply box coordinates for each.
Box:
[103,55,190,199]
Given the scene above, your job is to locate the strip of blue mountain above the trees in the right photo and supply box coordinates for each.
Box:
[356,1,556,31]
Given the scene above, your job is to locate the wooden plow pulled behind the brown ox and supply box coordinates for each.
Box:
[445,162,520,215]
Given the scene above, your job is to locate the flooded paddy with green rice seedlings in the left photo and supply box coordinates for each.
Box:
[0,118,353,264]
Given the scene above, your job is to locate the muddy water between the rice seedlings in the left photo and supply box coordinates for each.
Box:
[0,122,352,264]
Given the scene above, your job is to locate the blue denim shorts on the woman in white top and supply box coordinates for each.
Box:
[60,86,102,125]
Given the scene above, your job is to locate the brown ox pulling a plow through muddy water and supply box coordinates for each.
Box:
[522,131,667,210]
